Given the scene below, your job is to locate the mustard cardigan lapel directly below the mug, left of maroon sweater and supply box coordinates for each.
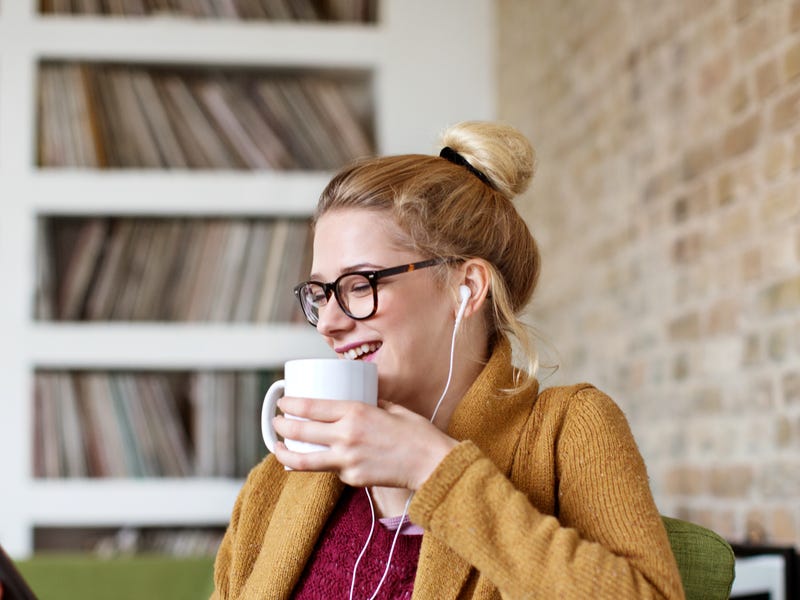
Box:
[244,472,344,598]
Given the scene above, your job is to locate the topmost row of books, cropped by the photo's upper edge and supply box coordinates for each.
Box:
[39,0,376,23]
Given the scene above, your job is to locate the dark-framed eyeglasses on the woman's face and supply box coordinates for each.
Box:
[294,258,447,327]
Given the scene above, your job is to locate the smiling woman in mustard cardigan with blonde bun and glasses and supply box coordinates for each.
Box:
[209,122,683,600]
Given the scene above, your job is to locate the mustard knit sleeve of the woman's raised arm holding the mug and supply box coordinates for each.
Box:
[410,388,683,600]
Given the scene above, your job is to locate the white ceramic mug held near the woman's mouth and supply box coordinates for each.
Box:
[261,358,378,452]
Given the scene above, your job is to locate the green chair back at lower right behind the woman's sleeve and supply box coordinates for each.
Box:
[662,516,736,600]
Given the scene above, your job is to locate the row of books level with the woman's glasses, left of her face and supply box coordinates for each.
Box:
[36,217,311,323]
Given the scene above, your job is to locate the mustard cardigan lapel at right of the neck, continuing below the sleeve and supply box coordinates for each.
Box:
[413,340,538,600]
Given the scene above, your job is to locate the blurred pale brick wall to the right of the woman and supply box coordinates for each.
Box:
[498,0,800,546]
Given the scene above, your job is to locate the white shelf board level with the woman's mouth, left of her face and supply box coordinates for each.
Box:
[27,323,334,370]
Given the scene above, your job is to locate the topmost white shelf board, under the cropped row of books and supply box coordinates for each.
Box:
[0,16,386,68]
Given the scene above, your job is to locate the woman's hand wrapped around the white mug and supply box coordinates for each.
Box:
[273,396,458,490]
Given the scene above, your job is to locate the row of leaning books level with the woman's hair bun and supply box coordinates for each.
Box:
[38,63,374,170]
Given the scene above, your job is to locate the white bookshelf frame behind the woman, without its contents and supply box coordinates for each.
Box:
[0,0,495,557]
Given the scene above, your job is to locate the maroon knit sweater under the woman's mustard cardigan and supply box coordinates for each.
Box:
[293,487,422,600]
